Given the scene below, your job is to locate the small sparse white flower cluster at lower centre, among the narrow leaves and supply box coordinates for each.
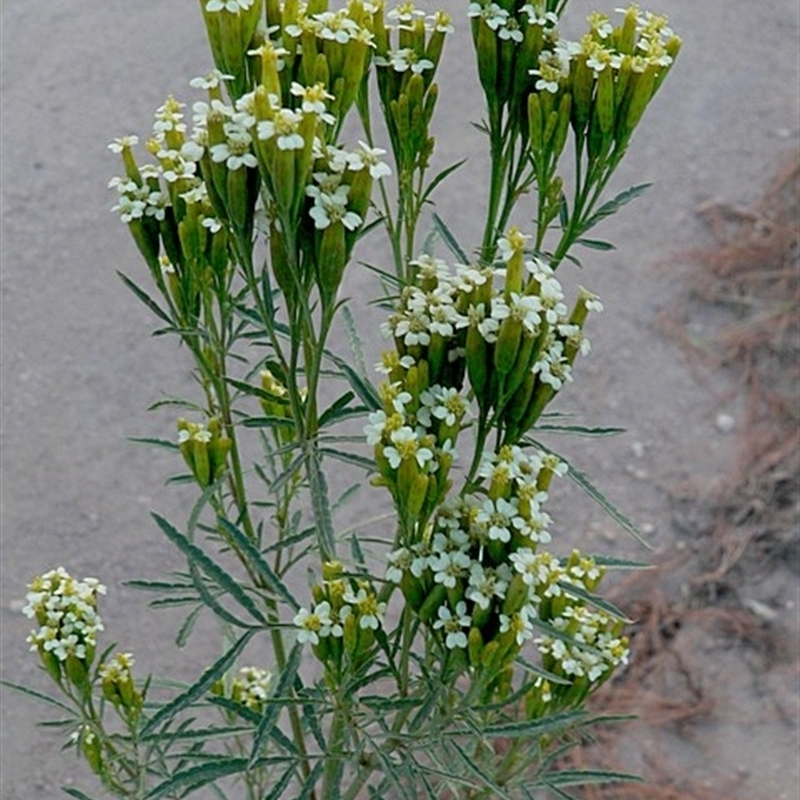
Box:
[294,562,386,674]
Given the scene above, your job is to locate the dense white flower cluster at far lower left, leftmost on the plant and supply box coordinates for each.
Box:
[23,567,106,689]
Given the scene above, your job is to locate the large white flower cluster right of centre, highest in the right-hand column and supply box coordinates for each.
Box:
[367,228,602,456]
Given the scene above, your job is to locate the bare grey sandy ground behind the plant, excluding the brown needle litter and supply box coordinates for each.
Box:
[0,0,800,800]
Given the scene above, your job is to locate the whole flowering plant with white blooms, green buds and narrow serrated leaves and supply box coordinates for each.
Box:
[10,0,680,800]
